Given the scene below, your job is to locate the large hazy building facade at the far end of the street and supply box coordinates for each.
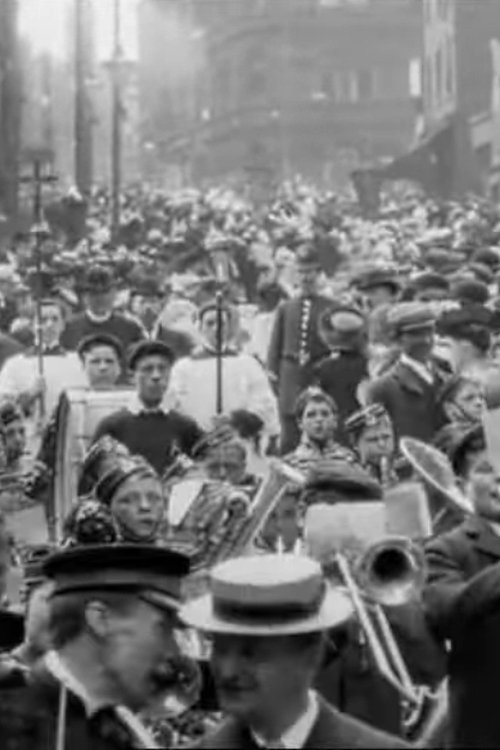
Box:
[139,0,422,191]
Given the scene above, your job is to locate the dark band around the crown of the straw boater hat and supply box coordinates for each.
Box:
[213,582,326,625]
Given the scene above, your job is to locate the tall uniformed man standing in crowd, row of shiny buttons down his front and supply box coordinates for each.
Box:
[268,245,332,454]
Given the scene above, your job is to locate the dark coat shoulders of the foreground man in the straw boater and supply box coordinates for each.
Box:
[193,700,410,750]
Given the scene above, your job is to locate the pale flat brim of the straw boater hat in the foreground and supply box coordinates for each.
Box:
[179,587,354,637]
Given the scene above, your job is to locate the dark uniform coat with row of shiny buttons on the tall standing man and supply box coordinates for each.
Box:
[267,295,333,416]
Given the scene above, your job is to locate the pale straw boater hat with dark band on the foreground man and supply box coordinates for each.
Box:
[180,555,353,637]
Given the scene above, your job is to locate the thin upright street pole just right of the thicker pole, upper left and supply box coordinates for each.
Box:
[111,0,123,237]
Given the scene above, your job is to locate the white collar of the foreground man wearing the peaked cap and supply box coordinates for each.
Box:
[44,651,158,748]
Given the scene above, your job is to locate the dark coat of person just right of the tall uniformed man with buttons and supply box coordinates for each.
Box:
[315,351,368,443]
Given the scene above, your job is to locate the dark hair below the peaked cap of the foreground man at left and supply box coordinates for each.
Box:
[49,589,136,649]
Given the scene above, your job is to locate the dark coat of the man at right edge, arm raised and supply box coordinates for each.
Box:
[424,518,500,748]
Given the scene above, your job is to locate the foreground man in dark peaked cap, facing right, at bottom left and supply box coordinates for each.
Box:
[0,544,193,750]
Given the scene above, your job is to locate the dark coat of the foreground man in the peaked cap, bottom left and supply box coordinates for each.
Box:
[0,670,139,750]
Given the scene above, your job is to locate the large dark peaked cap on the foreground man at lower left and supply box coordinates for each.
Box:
[43,544,190,610]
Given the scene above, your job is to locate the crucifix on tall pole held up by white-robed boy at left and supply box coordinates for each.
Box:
[20,151,58,418]
